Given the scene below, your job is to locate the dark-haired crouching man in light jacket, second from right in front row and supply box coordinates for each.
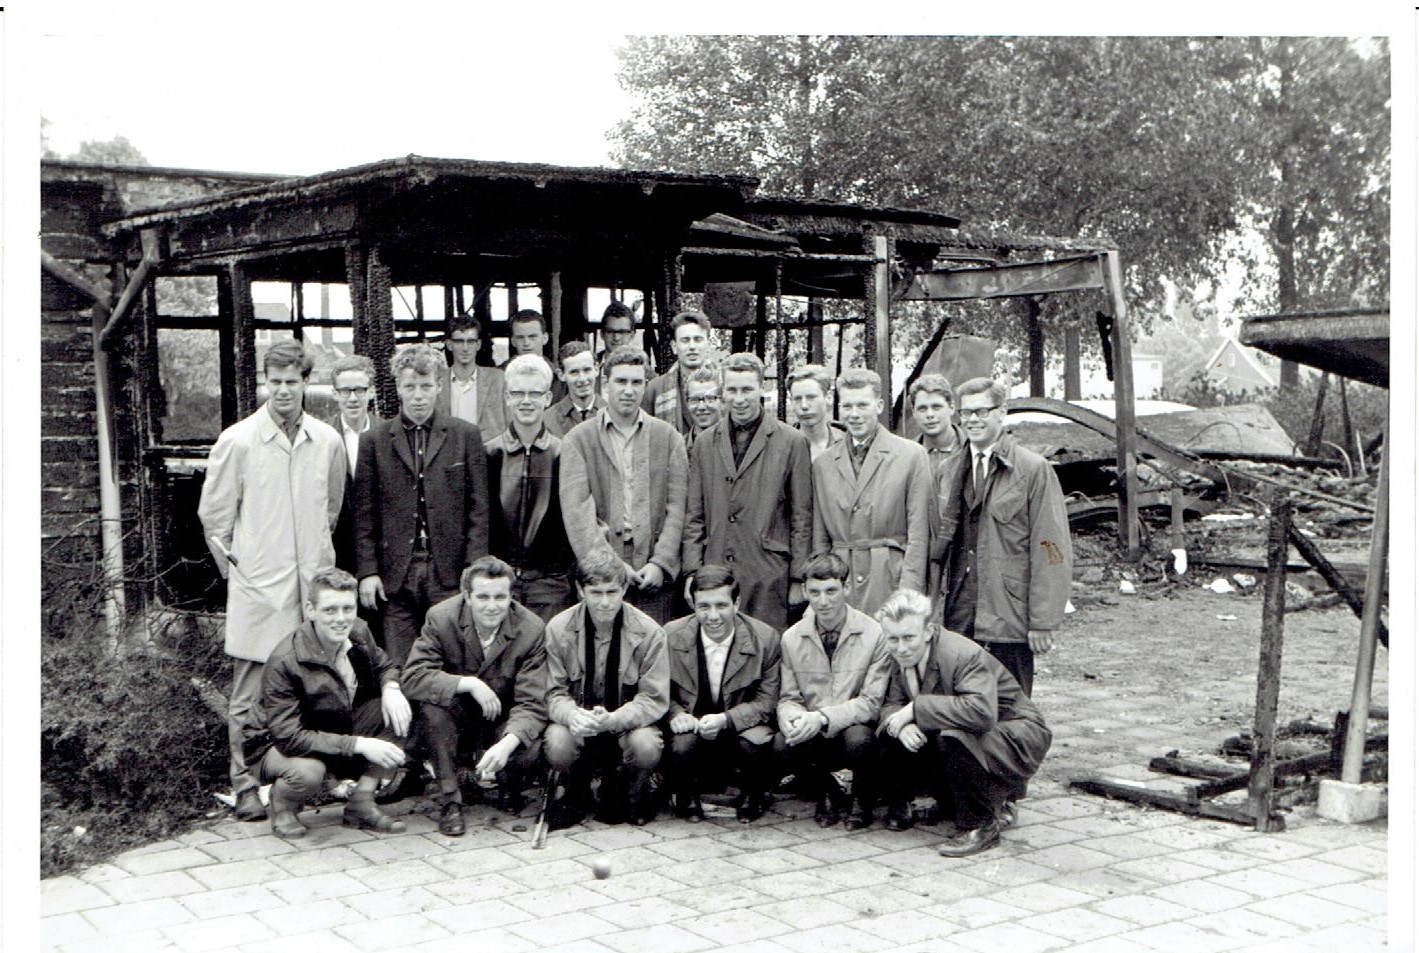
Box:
[773,553,891,830]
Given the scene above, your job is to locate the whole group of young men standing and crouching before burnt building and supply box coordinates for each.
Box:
[199,303,1070,857]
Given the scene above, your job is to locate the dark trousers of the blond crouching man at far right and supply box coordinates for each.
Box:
[880,732,1015,831]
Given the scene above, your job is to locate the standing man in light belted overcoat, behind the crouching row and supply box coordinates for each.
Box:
[813,367,934,614]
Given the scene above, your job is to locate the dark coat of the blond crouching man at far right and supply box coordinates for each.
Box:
[877,624,1053,780]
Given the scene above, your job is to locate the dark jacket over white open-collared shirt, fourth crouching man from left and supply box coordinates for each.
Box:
[666,613,779,745]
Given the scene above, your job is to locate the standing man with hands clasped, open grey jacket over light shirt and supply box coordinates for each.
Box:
[561,347,687,624]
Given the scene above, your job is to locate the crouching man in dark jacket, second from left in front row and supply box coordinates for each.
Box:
[404,555,546,837]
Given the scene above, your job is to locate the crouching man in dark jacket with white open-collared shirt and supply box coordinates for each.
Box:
[664,563,779,824]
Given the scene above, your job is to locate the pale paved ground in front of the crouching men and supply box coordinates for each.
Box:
[41,684,1388,953]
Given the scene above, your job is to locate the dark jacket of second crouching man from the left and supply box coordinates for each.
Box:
[403,593,546,747]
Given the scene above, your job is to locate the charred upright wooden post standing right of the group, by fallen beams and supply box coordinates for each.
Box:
[1247,489,1291,832]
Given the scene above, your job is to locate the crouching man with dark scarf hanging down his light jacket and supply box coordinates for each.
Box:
[543,549,670,827]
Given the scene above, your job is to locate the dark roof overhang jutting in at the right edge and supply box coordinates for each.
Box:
[1237,308,1389,387]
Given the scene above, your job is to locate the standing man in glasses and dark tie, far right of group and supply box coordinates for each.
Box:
[941,377,1071,695]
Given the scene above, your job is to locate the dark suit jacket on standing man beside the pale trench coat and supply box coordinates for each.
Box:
[355,410,488,593]
